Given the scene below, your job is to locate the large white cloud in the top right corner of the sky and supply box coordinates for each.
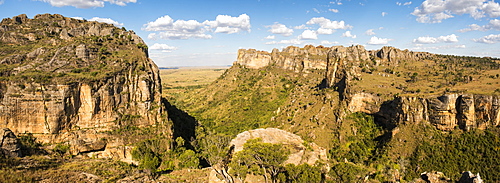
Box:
[412,0,500,23]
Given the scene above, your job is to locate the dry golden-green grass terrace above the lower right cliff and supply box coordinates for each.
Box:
[354,60,500,96]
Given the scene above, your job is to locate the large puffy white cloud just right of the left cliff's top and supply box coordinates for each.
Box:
[142,14,251,39]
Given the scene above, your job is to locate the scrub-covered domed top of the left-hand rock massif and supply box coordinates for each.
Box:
[0,15,148,84]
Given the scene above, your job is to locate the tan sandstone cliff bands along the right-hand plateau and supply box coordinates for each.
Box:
[236,45,500,130]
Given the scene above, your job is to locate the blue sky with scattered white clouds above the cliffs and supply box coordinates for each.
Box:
[0,0,500,67]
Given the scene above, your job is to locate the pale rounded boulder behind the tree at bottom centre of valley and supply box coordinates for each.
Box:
[230,128,327,165]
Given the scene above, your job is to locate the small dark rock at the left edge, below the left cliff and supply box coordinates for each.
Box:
[0,128,21,157]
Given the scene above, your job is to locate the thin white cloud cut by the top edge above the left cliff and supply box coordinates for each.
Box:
[38,0,137,8]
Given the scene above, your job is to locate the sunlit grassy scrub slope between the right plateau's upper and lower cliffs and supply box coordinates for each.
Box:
[351,55,500,96]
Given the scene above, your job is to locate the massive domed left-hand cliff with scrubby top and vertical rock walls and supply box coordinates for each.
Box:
[0,14,168,158]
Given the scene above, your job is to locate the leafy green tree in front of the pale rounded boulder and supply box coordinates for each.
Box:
[230,138,290,182]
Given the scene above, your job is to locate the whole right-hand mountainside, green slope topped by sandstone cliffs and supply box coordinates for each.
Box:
[173,46,500,182]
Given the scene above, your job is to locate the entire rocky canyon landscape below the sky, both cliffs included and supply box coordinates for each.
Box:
[0,14,500,182]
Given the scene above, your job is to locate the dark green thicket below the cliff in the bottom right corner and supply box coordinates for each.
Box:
[406,128,500,182]
